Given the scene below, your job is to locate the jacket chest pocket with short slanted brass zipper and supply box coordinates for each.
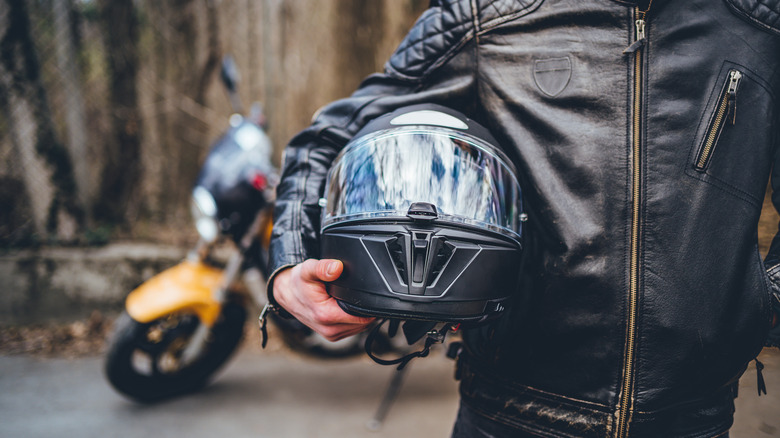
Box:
[685,61,775,208]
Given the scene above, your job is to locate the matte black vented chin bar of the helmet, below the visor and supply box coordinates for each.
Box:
[321,218,520,324]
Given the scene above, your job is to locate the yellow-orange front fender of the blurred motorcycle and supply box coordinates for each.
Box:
[125,261,222,327]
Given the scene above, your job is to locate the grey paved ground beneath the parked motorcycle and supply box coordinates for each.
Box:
[0,347,780,438]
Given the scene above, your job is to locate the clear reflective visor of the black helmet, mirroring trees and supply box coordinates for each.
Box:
[323,127,522,241]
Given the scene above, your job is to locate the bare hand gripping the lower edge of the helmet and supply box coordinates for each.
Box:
[273,259,374,341]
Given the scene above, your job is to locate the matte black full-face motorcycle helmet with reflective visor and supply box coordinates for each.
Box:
[321,104,524,324]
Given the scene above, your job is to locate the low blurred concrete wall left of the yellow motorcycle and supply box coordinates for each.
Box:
[0,243,186,324]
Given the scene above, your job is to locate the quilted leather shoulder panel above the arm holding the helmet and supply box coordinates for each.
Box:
[385,0,544,80]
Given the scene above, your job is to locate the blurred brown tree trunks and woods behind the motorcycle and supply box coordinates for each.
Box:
[0,0,428,247]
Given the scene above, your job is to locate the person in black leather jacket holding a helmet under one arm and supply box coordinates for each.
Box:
[269,0,780,437]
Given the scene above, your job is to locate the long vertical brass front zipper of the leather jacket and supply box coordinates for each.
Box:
[615,8,649,438]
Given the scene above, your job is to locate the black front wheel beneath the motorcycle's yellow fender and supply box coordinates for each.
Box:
[104,301,246,403]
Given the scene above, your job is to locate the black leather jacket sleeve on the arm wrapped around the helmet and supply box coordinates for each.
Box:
[268,1,478,290]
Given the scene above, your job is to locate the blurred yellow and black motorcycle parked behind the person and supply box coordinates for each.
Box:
[104,58,363,402]
